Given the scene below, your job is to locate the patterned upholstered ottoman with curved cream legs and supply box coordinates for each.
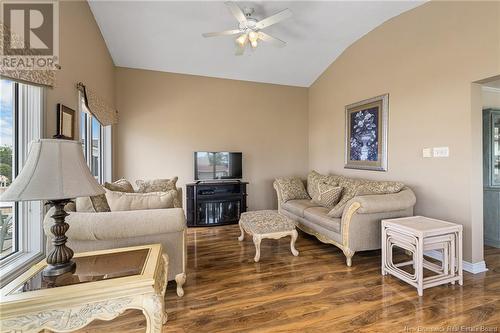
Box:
[238,210,299,262]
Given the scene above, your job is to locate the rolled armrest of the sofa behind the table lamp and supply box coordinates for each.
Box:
[43,208,186,240]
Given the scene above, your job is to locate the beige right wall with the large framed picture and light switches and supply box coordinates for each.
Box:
[309,2,500,262]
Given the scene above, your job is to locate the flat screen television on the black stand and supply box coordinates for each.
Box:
[194,151,243,180]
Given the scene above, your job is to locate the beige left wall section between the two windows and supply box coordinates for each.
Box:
[45,1,115,138]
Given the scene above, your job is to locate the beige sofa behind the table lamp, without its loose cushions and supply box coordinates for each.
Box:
[44,189,187,296]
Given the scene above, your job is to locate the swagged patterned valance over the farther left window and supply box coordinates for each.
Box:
[76,82,118,126]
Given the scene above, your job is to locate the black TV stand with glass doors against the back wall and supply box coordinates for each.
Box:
[186,180,248,227]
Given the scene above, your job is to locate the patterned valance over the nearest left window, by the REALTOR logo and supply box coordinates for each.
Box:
[0,23,56,87]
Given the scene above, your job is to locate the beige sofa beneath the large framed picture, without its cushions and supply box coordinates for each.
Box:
[274,172,416,266]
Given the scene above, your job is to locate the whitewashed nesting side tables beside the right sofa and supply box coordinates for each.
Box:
[382,216,463,296]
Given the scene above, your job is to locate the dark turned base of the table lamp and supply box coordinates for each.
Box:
[42,199,76,276]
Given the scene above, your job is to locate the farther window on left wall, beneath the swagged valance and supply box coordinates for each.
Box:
[80,99,111,183]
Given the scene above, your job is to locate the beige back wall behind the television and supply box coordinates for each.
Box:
[115,68,308,209]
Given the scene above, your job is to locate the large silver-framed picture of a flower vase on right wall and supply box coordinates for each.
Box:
[344,94,389,171]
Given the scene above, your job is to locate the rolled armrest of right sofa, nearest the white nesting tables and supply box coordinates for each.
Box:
[344,188,417,214]
